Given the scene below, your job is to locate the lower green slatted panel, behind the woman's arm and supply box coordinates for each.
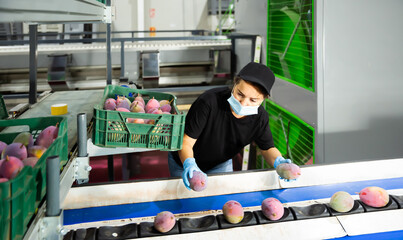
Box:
[256,100,315,168]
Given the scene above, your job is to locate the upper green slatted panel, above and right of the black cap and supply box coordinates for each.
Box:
[267,0,315,91]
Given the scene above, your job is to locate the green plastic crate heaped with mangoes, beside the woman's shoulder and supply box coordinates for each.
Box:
[92,85,185,151]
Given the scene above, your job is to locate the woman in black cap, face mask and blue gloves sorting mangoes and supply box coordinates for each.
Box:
[168,62,291,190]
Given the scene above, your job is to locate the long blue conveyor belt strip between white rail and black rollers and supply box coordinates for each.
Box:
[64,177,403,225]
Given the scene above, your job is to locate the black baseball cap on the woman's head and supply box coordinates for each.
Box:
[238,62,275,95]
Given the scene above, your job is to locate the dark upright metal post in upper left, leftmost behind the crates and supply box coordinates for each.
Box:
[29,24,38,104]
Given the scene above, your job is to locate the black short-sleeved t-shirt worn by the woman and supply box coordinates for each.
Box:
[173,87,274,171]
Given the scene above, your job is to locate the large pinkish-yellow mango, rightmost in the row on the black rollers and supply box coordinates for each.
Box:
[359,187,389,207]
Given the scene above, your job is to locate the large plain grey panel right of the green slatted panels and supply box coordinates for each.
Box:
[315,0,403,163]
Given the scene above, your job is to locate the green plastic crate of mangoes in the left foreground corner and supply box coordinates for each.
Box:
[0,117,68,240]
